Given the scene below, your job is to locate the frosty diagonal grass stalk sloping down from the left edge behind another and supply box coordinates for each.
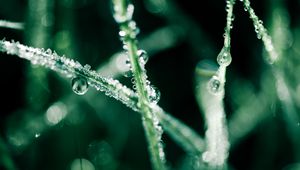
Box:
[0,40,204,168]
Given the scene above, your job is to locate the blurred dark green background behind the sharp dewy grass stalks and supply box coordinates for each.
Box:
[0,0,300,170]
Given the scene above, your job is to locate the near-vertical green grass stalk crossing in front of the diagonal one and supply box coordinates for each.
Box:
[113,0,166,170]
